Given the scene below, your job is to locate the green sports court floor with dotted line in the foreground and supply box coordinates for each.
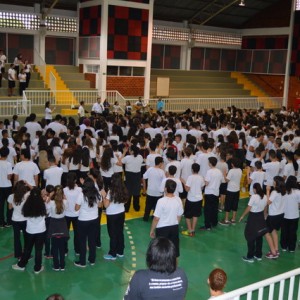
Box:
[0,198,300,300]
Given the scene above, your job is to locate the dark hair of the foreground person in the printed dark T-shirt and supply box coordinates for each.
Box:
[146,237,176,274]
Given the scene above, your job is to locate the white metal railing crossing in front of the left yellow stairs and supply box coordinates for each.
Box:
[23,90,126,107]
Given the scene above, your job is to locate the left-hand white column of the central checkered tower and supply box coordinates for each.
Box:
[98,0,109,96]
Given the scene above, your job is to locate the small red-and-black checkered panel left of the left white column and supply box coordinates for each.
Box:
[79,5,101,36]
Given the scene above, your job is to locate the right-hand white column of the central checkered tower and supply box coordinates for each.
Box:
[144,0,154,101]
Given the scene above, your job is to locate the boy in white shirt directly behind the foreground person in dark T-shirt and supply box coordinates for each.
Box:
[150,179,183,257]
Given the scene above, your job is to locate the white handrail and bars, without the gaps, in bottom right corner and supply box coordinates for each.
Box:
[214,268,300,300]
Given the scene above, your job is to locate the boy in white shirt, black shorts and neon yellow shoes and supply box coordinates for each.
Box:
[181,163,205,237]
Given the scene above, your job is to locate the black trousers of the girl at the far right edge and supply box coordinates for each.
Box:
[280,219,299,251]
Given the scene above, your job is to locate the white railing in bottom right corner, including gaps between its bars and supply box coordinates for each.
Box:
[214,268,300,300]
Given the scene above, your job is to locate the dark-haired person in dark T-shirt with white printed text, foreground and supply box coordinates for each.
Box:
[124,237,188,300]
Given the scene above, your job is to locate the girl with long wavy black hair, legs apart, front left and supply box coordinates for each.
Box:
[12,187,47,274]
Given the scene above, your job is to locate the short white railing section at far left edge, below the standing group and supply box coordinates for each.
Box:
[0,98,31,117]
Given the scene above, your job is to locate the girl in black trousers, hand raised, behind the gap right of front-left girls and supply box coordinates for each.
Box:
[117,145,144,212]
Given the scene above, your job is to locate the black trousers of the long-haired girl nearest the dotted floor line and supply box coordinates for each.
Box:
[107,212,125,257]
